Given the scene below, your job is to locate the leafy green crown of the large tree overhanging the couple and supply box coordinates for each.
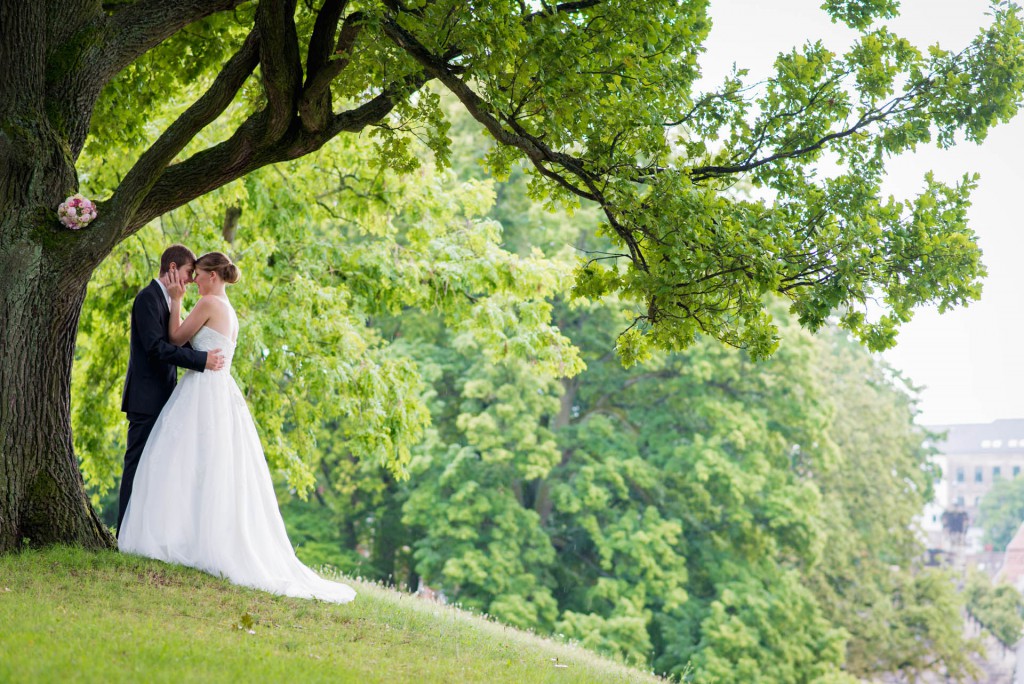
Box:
[83,0,1024,365]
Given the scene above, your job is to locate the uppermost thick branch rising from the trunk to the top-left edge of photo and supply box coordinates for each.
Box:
[97,0,246,78]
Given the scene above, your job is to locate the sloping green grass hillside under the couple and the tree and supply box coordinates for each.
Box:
[0,547,664,684]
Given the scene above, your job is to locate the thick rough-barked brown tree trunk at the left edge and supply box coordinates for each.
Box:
[0,2,114,553]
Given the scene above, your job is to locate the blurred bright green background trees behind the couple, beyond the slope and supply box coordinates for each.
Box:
[75,98,972,681]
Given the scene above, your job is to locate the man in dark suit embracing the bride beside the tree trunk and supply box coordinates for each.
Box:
[118,245,224,532]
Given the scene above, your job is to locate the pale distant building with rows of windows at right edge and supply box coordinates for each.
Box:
[922,419,1024,571]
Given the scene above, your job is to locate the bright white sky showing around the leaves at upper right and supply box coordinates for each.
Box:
[701,0,1024,425]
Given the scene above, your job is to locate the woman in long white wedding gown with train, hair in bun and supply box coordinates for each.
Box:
[118,252,355,603]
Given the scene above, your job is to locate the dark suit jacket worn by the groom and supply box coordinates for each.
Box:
[121,281,206,416]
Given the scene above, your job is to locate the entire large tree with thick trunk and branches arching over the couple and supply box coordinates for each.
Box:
[0,0,1024,552]
